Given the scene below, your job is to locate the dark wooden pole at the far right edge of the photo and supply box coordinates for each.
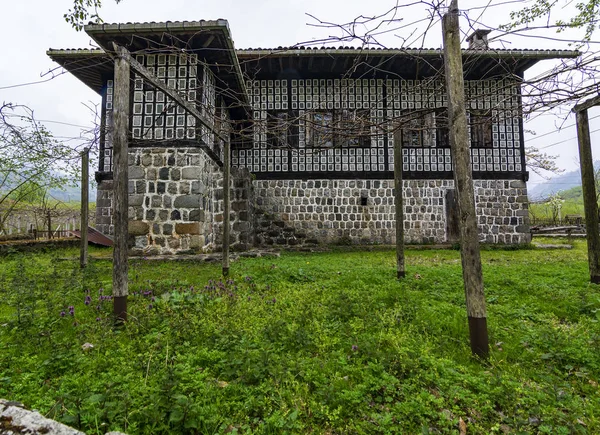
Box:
[575,109,600,284]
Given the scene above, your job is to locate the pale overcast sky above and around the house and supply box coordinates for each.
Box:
[0,0,600,194]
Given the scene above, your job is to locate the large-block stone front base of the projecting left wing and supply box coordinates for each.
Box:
[129,147,222,255]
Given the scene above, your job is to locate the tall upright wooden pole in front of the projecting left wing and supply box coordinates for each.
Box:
[113,48,130,323]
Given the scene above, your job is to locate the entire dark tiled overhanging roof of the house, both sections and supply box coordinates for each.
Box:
[48,19,579,109]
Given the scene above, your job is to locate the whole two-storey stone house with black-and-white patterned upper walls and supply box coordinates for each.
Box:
[48,20,577,254]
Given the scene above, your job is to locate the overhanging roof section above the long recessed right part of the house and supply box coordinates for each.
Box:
[237,47,579,79]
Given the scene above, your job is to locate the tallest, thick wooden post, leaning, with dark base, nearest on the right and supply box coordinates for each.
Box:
[442,0,489,358]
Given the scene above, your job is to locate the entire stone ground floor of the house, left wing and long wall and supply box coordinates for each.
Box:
[96,169,531,255]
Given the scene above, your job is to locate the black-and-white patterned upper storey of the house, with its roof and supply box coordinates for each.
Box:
[48,20,578,178]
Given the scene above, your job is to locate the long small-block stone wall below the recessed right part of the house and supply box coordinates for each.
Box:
[254,180,531,246]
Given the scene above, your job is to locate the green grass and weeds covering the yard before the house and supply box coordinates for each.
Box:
[0,241,600,434]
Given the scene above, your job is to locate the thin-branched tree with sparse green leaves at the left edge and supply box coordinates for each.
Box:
[0,103,77,231]
